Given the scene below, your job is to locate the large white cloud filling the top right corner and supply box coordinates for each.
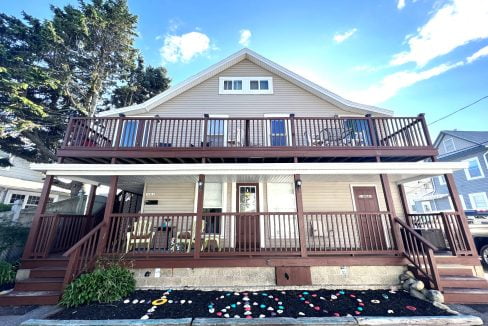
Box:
[390,0,488,66]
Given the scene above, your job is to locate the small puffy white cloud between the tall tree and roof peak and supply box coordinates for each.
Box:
[160,32,210,63]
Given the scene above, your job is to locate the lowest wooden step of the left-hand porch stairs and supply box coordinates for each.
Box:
[0,291,61,306]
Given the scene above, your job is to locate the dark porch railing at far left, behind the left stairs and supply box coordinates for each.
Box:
[27,214,92,258]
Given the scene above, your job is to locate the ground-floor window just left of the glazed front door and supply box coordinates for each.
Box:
[203,183,223,233]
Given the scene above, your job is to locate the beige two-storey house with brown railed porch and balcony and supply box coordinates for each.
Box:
[0,49,488,304]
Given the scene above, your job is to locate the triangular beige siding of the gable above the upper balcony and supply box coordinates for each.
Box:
[140,60,357,117]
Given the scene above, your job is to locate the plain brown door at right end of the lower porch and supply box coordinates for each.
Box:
[353,186,387,250]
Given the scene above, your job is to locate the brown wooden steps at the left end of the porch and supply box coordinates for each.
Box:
[0,256,68,306]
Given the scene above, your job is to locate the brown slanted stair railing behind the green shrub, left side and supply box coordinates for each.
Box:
[63,222,104,287]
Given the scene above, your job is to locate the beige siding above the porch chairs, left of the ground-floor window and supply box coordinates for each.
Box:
[143,181,195,213]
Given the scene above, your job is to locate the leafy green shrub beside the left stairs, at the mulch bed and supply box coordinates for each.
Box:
[60,265,136,307]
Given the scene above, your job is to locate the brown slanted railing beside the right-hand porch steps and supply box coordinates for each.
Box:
[395,217,442,291]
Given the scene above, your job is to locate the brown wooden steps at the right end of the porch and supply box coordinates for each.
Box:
[436,257,488,304]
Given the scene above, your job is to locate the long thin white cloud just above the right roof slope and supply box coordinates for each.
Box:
[349,61,464,104]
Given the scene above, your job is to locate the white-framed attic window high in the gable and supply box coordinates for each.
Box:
[219,77,273,94]
